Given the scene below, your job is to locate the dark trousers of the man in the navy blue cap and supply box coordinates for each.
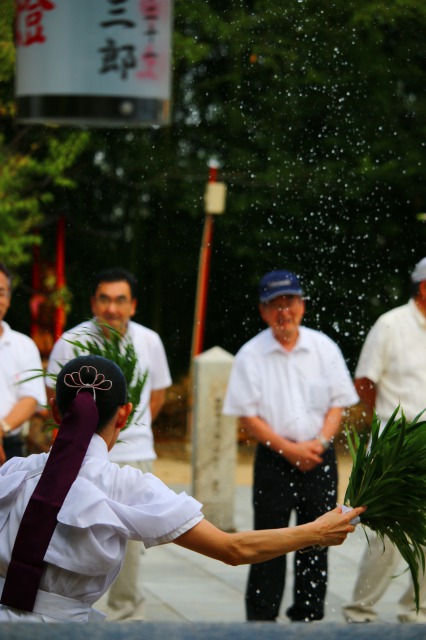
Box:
[246,445,337,621]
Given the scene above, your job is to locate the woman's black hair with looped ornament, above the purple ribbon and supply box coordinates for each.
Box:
[56,355,127,432]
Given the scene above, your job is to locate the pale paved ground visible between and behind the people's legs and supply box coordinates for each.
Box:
[95,452,408,624]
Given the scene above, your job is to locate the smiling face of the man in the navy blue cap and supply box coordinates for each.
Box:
[259,295,305,346]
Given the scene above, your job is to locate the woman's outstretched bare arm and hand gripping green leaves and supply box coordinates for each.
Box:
[175,507,365,566]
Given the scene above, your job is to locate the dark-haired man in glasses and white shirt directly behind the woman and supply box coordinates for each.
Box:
[47,268,172,620]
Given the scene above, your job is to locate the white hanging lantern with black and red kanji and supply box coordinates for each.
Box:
[15,0,173,126]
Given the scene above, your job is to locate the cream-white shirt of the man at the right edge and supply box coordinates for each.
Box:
[355,300,426,423]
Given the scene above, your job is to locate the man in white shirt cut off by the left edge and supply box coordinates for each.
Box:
[0,263,46,464]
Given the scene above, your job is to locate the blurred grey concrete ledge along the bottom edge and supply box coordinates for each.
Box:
[0,622,426,640]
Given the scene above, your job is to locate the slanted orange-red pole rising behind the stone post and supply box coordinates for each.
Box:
[191,164,218,363]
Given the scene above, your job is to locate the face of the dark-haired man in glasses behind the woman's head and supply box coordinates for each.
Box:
[91,280,136,335]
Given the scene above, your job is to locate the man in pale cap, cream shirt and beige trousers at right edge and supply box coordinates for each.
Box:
[343,258,426,623]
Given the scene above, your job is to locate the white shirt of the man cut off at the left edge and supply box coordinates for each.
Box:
[0,322,47,437]
